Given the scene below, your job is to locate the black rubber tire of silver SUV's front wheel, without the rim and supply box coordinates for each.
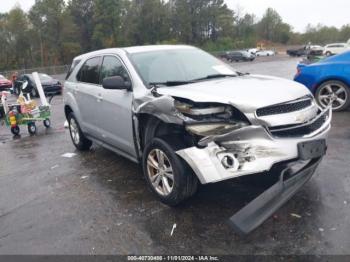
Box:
[142,138,198,206]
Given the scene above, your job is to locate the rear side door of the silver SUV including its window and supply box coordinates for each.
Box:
[73,56,103,138]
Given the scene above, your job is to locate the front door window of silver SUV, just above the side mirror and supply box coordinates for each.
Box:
[100,56,130,83]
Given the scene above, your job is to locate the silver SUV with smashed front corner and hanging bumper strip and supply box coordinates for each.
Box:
[64,46,332,233]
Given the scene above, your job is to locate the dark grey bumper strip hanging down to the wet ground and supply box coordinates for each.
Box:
[229,157,322,235]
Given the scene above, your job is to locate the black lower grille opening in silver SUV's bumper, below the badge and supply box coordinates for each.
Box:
[270,110,329,138]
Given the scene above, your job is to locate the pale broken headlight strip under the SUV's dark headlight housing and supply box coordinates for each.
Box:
[186,122,247,136]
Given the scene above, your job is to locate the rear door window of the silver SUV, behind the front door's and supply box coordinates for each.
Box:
[77,57,101,84]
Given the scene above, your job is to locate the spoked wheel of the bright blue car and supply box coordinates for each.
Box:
[315,80,350,112]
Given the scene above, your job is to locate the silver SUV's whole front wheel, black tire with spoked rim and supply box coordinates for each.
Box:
[142,138,198,206]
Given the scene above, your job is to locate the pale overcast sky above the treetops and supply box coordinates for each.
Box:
[0,0,350,32]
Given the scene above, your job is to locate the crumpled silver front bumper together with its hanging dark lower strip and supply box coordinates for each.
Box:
[177,108,332,234]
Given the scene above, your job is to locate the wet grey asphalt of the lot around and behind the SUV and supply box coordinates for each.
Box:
[0,57,350,255]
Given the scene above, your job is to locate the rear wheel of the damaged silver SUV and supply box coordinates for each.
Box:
[67,112,92,151]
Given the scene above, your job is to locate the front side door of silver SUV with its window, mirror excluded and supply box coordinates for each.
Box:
[98,55,136,157]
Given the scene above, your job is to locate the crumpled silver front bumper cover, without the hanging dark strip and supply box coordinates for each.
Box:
[177,108,332,184]
